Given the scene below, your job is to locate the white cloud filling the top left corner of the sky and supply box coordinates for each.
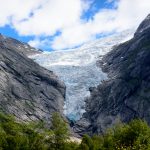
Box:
[0,0,43,26]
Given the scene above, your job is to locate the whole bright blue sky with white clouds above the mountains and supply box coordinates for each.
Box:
[0,0,150,51]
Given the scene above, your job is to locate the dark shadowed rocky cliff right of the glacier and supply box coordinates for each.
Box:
[76,15,150,133]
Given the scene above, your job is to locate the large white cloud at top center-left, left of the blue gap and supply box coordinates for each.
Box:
[14,0,86,36]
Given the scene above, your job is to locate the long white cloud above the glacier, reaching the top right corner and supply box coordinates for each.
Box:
[52,0,150,49]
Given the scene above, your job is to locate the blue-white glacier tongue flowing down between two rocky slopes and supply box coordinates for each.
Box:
[30,30,134,120]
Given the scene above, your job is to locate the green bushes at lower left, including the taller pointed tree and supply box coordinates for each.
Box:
[0,113,71,150]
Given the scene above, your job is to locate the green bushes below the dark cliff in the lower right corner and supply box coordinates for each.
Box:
[81,120,150,150]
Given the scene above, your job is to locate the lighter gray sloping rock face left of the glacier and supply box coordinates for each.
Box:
[0,36,65,121]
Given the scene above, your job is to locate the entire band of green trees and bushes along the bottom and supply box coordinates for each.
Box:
[0,113,150,150]
